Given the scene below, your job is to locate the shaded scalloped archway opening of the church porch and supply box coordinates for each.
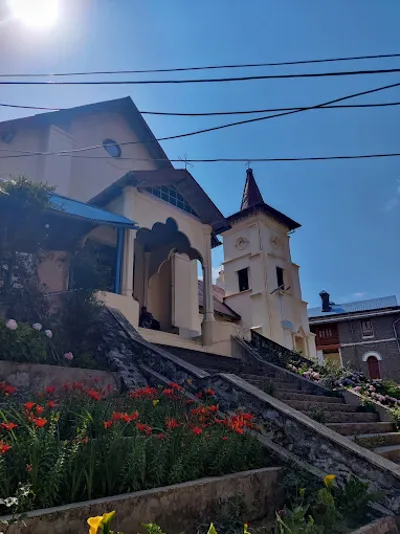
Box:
[133,218,202,337]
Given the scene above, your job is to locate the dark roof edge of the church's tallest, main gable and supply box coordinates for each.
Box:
[0,96,173,169]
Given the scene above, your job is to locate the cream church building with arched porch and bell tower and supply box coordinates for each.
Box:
[0,98,315,356]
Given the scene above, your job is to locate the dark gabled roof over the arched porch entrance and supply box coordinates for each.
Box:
[90,169,230,238]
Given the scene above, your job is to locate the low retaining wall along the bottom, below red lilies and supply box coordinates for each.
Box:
[3,467,283,534]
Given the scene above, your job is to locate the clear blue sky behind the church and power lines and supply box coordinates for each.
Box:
[0,0,400,305]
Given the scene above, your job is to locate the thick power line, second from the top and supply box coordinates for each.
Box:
[0,69,400,85]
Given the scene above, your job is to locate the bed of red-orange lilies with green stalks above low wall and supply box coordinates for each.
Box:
[0,383,267,512]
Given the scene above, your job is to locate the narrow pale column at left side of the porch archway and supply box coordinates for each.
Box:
[121,186,136,297]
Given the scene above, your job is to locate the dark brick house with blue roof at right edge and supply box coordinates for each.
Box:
[308,291,400,380]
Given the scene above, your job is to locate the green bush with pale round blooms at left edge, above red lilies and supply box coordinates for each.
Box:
[0,319,47,363]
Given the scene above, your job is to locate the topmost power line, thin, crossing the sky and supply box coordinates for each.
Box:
[0,54,400,78]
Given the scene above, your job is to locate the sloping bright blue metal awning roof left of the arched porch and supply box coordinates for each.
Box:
[50,194,139,230]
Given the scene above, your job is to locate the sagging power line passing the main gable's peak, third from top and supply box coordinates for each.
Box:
[0,101,400,117]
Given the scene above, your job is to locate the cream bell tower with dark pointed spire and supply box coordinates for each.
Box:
[222,169,316,356]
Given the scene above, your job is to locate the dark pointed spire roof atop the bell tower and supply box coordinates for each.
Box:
[226,169,301,230]
